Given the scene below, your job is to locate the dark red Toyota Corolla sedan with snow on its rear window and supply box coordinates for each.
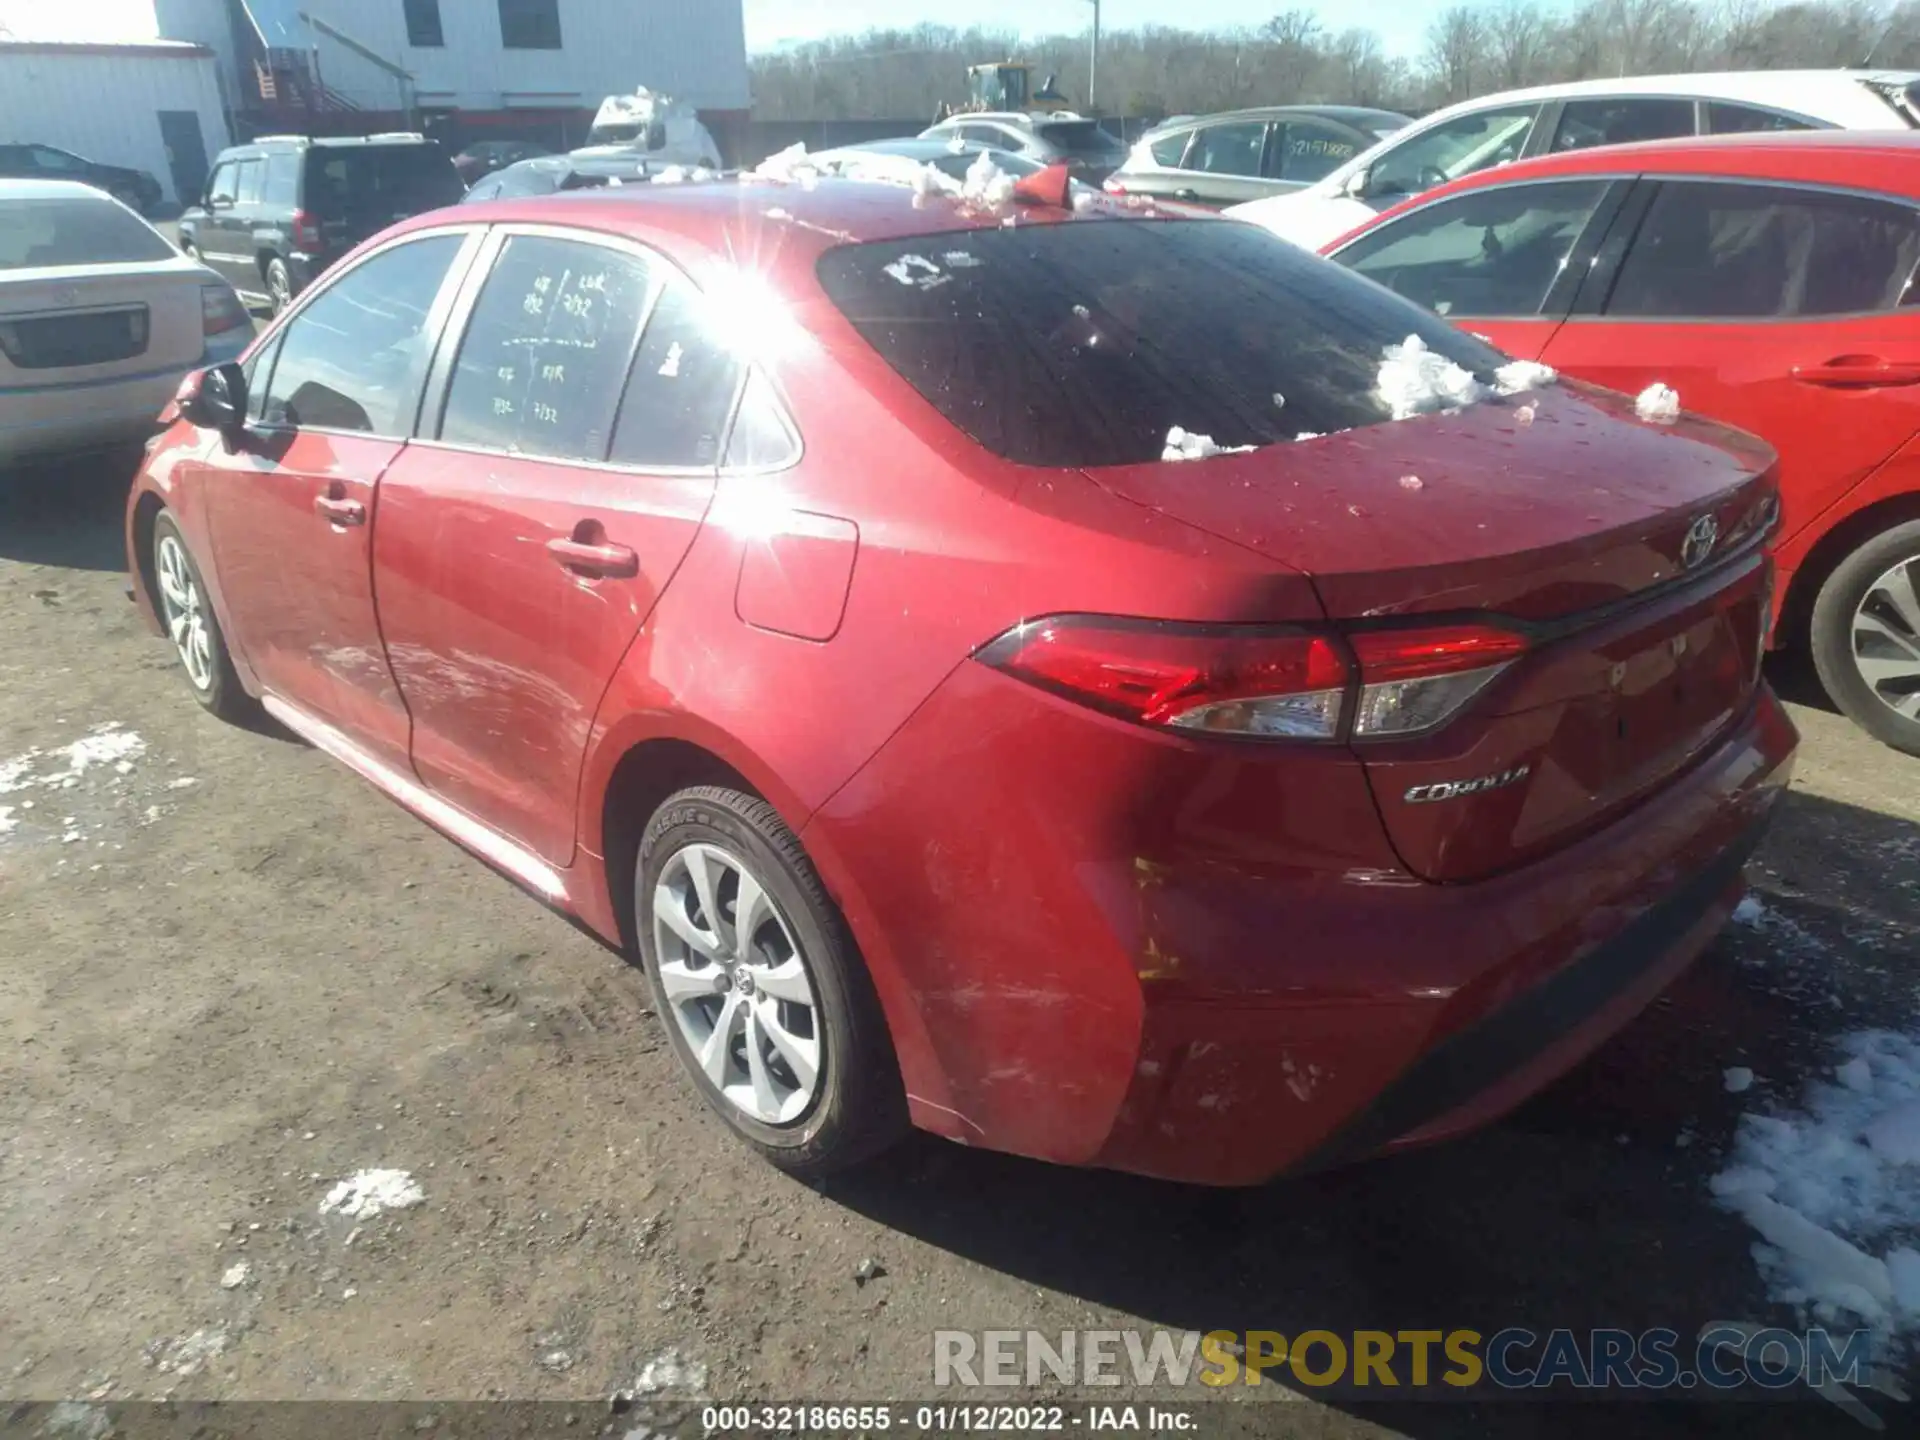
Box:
[127,171,1795,1183]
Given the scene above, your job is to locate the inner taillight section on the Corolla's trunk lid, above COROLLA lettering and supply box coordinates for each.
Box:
[1348,624,1526,739]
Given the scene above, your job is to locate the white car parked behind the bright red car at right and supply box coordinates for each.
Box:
[1227,69,1920,250]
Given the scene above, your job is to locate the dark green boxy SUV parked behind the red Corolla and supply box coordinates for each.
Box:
[180,134,467,315]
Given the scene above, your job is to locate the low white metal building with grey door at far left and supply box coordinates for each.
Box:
[0,40,228,204]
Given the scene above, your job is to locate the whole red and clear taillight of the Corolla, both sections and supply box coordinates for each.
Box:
[975,616,1526,739]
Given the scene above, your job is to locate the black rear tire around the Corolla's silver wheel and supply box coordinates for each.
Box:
[634,785,906,1177]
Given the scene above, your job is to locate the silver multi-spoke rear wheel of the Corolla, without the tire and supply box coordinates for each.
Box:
[653,843,824,1125]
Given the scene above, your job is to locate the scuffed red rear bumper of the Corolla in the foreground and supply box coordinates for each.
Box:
[806,666,1795,1185]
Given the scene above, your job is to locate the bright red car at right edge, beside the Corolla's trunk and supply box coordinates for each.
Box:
[1327,131,1920,755]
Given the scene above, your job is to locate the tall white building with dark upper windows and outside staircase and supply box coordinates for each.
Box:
[154,0,749,129]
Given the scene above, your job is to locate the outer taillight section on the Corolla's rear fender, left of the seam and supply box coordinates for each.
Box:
[977,616,1350,739]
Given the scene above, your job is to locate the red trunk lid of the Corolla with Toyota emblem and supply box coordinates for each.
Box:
[1089,386,1776,881]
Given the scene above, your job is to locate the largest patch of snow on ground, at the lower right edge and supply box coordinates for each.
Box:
[1711,1031,1920,1340]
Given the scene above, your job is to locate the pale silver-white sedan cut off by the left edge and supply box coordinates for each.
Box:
[0,180,253,467]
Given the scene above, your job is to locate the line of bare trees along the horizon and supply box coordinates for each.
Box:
[753,0,1920,121]
